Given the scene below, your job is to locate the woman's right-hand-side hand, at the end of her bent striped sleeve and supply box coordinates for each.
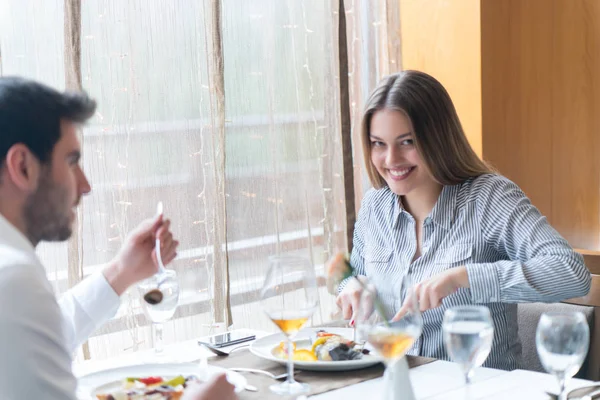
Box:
[392,266,469,321]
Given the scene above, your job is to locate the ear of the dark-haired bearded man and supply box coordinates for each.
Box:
[4,143,41,192]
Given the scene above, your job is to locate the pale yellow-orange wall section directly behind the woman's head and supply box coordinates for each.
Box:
[400,0,482,155]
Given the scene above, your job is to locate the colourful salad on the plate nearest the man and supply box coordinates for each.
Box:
[96,375,198,400]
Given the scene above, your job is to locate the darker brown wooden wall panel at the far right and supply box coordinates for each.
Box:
[481,0,600,250]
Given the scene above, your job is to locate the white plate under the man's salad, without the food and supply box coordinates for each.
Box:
[77,363,247,400]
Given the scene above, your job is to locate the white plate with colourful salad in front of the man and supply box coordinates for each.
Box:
[77,363,247,400]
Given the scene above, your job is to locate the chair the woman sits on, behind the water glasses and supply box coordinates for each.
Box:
[518,250,600,381]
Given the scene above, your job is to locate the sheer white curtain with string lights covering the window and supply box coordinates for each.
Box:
[0,0,404,358]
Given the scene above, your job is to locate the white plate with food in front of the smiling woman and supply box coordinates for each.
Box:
[250,328,382,371]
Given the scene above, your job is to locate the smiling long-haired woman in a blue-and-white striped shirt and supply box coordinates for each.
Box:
[337,71,591,370]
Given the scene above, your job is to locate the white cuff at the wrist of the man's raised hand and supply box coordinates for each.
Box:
[71,272,121,321]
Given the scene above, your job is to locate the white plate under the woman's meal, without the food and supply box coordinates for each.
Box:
[250,327,381,371]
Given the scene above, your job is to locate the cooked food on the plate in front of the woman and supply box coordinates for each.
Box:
[271,330,368,361]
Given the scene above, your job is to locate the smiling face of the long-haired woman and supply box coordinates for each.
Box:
[369,109,435,196]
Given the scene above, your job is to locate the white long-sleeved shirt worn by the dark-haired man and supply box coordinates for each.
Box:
[0,215,120,400]
